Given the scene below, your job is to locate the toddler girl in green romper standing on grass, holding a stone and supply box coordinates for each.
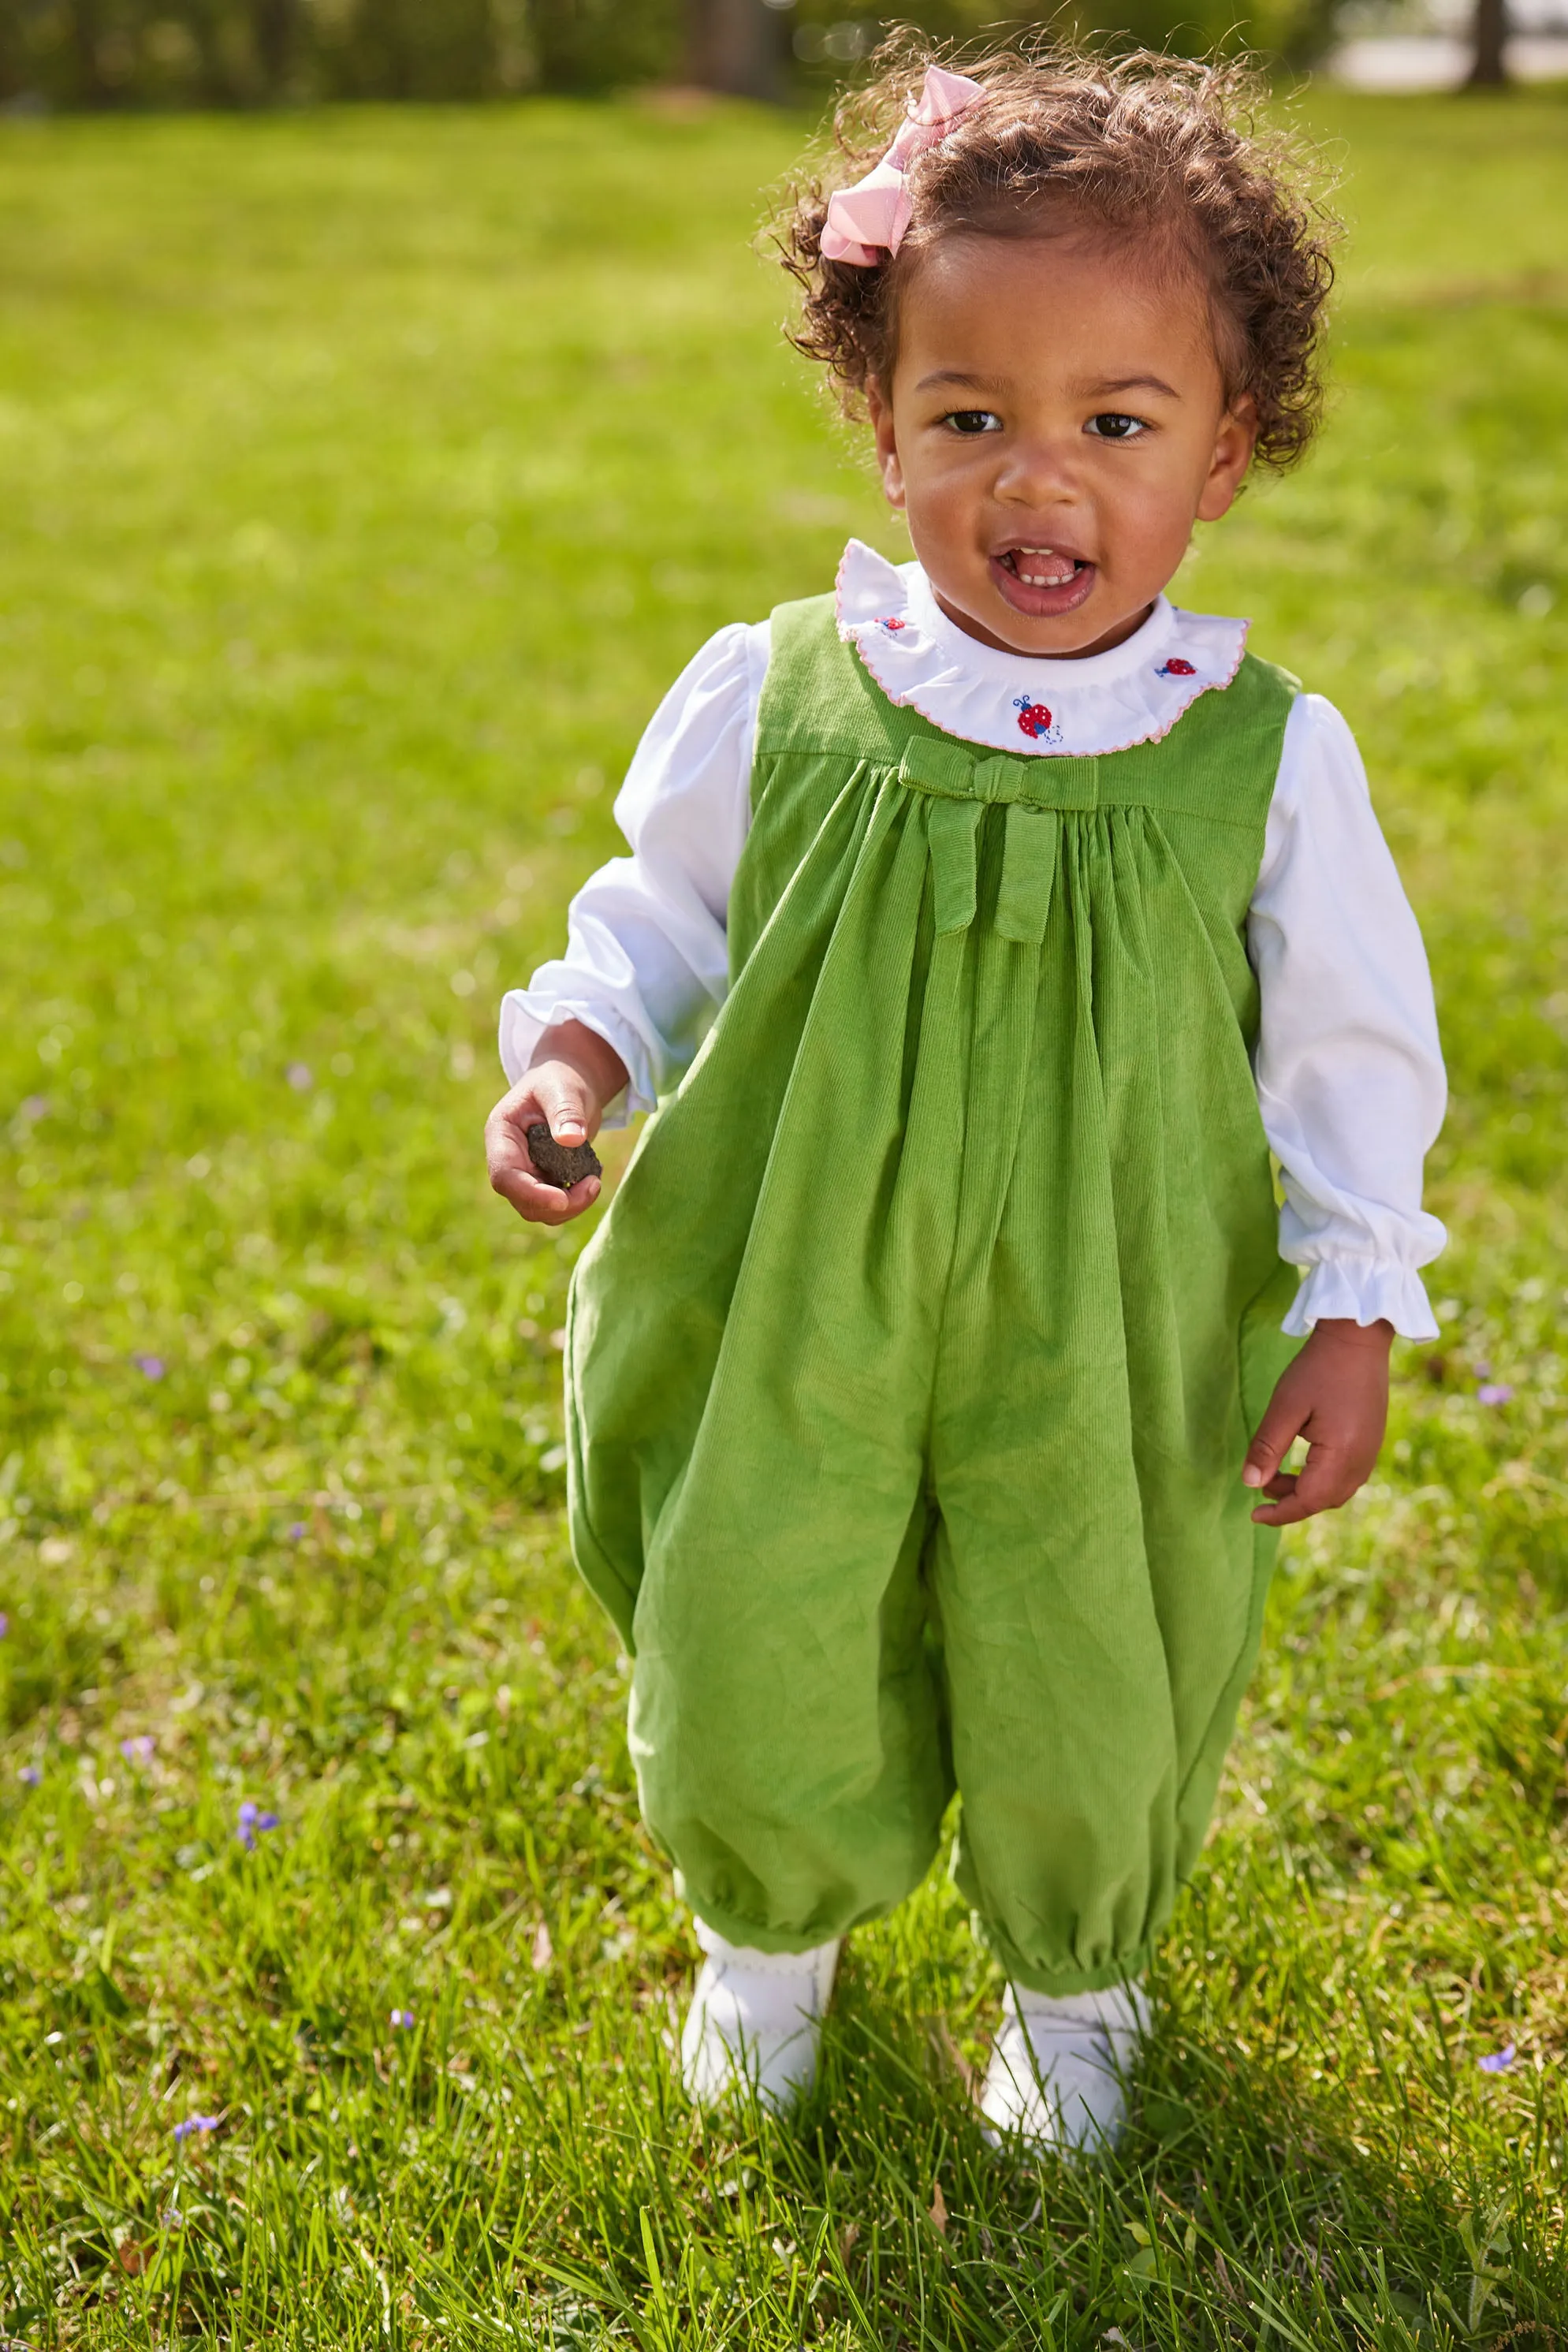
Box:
[489,52,1443,2149]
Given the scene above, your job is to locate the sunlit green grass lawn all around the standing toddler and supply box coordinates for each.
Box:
[0,83,1568,2352]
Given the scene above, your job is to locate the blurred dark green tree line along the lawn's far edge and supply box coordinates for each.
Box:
[0,0,1354,108]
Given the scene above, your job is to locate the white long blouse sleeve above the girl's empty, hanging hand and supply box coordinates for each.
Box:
[1248,694,1446,1338]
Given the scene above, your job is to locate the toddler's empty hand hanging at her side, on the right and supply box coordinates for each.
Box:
[1242,1319,1394,1526]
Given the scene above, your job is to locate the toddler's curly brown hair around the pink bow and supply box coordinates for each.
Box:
[776,31,1338,471]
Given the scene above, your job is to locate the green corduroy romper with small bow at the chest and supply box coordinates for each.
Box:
[567,598,1295,1992]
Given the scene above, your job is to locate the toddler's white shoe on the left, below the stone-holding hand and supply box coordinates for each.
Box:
[682,1919,840,2115]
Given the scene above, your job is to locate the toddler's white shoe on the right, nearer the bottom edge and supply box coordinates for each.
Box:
[980,1985,1149,2156]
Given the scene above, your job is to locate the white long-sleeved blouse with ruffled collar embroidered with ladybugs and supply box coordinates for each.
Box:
[501,541,1446,1338]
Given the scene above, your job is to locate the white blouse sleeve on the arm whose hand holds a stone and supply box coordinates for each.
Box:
[501,621,769,1127]
